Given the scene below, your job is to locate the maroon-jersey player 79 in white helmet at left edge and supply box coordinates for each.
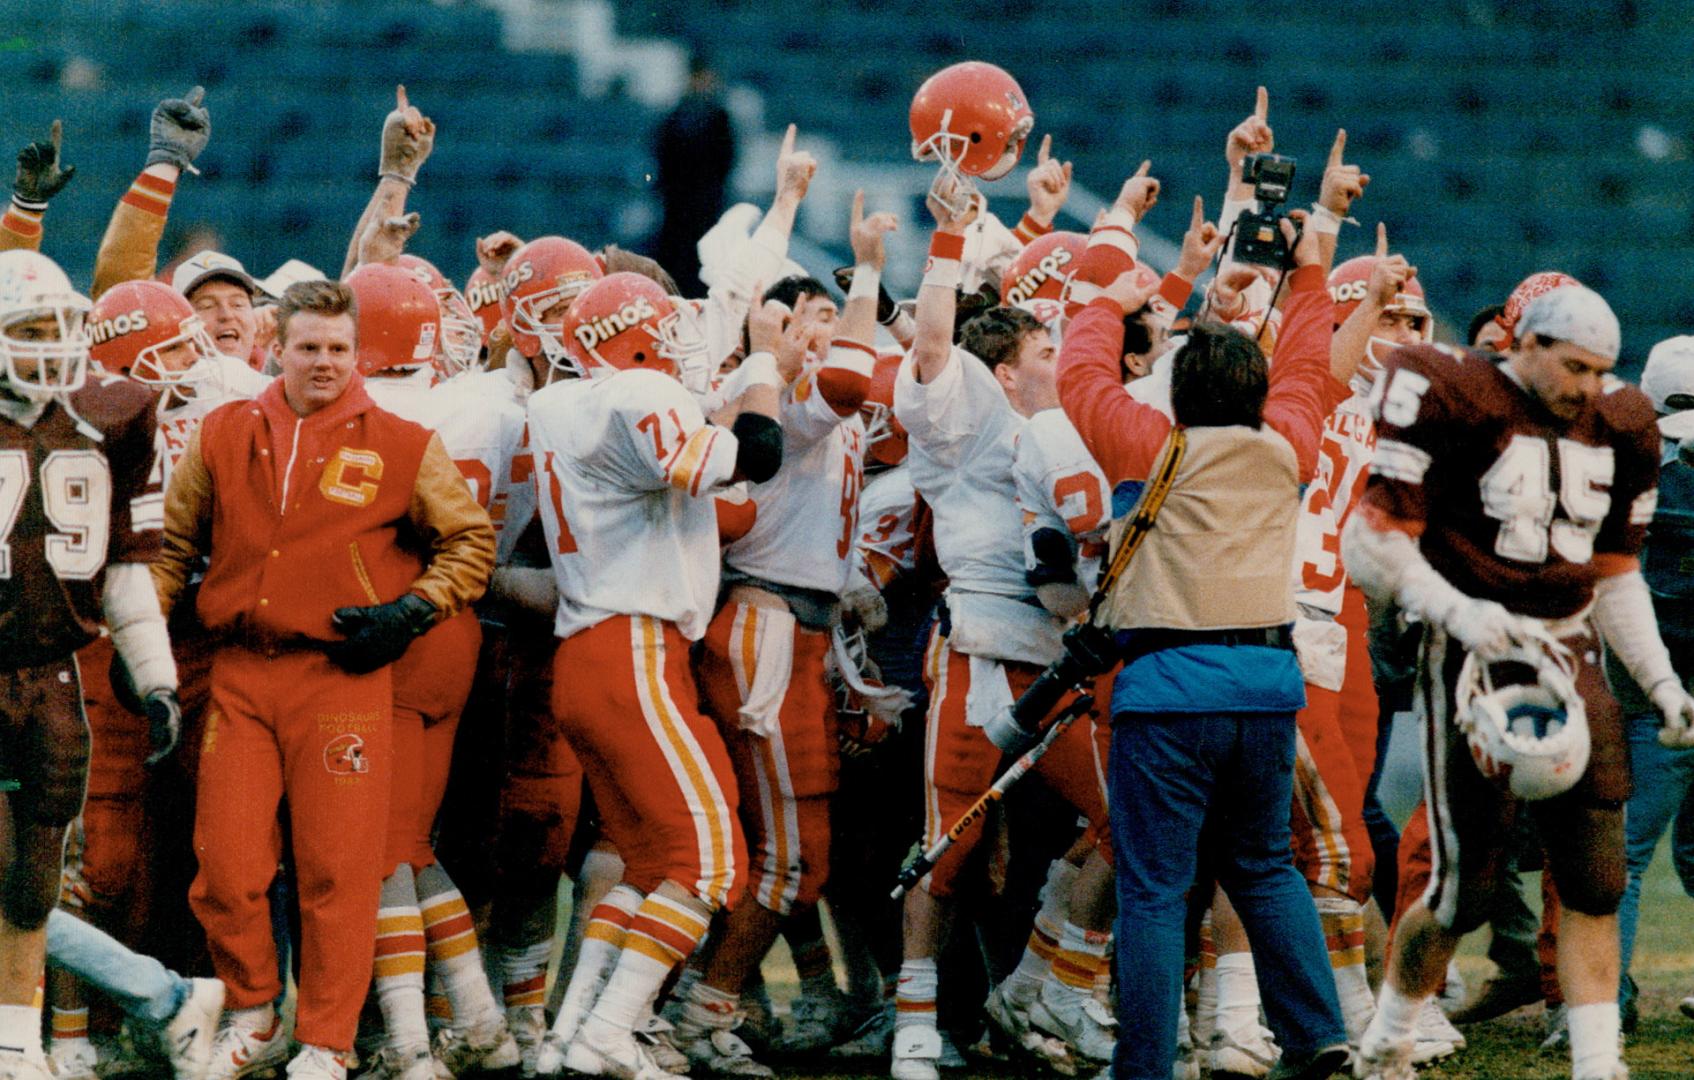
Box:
[0,251,181,1078]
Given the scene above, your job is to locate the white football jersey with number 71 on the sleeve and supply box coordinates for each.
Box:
[529,371,739,642]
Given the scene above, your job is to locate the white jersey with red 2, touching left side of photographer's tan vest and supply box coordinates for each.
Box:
[1013,408,1111,592]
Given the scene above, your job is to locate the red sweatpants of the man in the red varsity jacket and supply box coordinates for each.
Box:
[188,645,393,1050]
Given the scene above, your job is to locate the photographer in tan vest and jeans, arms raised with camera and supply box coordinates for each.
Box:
[1059,169,1347,1080]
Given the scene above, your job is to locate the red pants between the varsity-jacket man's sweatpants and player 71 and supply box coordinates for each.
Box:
[383,608,483,873]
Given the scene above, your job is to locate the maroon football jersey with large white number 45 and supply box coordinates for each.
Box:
[1365,345,1658,618]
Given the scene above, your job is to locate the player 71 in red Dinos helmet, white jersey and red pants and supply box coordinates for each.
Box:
[528,273,784,1078]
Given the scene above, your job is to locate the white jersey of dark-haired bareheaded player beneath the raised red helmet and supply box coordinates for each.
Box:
[894,347,1060,664]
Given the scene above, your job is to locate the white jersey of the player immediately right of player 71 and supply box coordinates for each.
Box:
[723,345,872,596]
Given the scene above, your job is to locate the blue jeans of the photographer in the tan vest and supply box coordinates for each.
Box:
[1108,713,1347,1080]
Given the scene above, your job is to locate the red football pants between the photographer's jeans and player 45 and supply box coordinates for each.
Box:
[1291,586,1377,904]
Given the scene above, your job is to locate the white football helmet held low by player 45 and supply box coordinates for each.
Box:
[1453,642,1589,799]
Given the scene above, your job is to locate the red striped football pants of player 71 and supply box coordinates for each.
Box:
[552,614,747,907]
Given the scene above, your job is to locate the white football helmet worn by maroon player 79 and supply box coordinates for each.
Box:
[0,249,91,399]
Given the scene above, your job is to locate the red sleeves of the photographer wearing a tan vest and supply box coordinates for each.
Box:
[1059,266,1337,484]
